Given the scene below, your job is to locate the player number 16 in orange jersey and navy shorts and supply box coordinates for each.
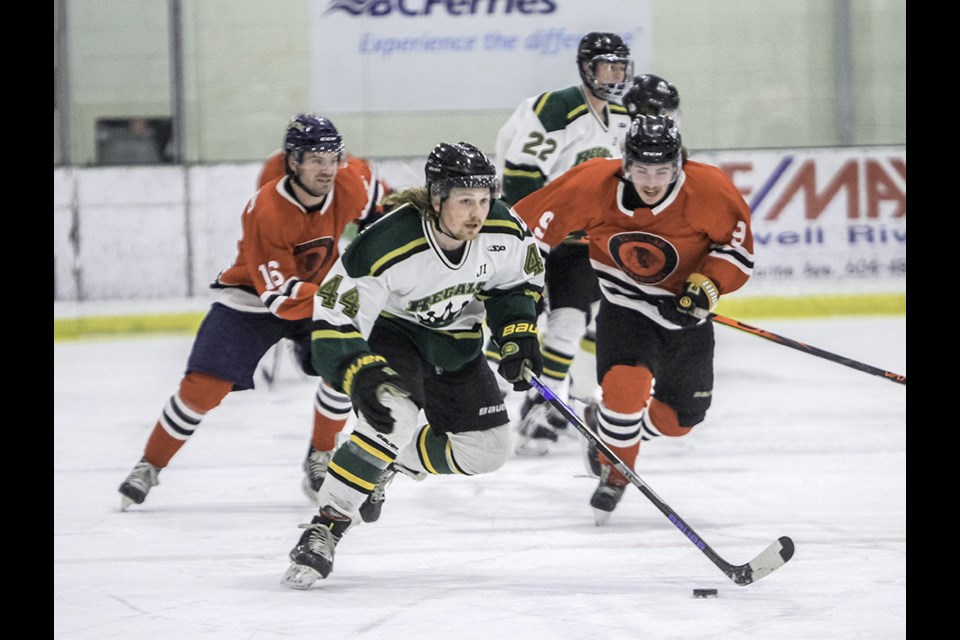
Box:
[119,113,378,509]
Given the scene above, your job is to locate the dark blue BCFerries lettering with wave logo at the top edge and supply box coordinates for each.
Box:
[324,0,557,18]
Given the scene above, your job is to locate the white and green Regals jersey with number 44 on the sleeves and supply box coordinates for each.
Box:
[312,200,544,385]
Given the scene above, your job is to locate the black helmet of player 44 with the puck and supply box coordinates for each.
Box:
[424,142,500,200]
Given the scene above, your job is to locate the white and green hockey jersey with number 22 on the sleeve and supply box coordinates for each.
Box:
[494,86,630,204]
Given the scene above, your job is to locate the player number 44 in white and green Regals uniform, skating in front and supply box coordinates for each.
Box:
[282,142,544,589]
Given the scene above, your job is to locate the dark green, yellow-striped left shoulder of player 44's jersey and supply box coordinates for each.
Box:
[343,204,429,278]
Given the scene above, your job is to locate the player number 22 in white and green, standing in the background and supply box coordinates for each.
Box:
[487,31,633,455]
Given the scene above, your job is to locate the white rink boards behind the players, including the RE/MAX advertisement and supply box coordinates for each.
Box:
[54,147,907,301]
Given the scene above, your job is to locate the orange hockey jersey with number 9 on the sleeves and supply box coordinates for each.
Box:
[513,159,753,329]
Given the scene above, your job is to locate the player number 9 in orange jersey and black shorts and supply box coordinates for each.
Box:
[514,115,753,525]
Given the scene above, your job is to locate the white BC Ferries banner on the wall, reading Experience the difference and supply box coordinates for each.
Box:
[309,0,651,112]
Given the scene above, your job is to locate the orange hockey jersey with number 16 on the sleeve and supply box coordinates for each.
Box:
[212,163,377,320]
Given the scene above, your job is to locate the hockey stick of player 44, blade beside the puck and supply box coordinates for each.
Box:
[523,369,794,587]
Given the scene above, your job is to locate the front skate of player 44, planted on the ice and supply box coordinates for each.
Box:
[280,505,352,589]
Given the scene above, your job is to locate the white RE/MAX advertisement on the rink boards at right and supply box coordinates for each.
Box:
[691,147,907,294]
